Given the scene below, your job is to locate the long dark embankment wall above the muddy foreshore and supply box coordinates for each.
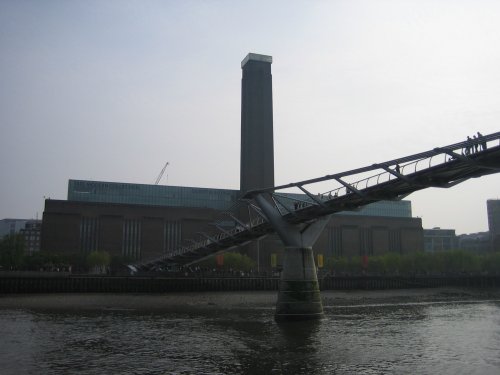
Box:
[0,274,500,294]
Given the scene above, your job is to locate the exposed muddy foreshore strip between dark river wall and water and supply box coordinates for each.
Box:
[0,287,500,312]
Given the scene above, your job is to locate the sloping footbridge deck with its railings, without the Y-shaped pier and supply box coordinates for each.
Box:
[134,132,500,270]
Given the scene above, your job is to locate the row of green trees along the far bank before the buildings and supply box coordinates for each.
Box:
[0,234,500,275]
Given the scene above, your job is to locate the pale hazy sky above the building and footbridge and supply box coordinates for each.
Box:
[0,0,500,234]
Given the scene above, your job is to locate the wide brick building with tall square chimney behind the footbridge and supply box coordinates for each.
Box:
[41,53,424,270]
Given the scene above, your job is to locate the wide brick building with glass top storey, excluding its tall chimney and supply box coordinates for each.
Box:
[42,180,423,270]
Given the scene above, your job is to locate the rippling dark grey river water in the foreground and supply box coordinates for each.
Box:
[0,302,500,374]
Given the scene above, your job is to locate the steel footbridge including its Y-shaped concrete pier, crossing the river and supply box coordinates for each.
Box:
[130,132,500,321]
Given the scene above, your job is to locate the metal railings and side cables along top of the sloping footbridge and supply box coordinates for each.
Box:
[134,132,500,265]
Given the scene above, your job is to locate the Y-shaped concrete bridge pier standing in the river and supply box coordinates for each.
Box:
[255,194,329,322]
